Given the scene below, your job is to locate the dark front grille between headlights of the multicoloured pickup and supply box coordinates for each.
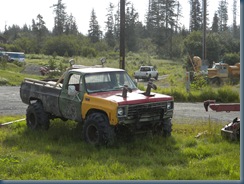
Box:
[128,102,167,117]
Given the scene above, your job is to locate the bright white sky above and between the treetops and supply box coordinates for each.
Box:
[0,0,240,35]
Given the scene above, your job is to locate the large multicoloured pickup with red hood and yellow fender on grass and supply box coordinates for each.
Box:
[20,65,174,145]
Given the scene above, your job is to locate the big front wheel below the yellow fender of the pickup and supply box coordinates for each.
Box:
[83,113,115,146]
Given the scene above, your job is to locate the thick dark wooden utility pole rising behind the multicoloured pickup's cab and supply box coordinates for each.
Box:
[119,0,125,69]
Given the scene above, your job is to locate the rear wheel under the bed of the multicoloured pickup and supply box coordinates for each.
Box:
[26,102,50,130]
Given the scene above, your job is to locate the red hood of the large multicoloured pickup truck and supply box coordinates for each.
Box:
[89,90,174,105]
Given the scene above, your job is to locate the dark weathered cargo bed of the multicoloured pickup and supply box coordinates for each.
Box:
[20,78,62,116]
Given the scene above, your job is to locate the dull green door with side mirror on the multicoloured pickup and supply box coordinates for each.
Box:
[59,73,84,121]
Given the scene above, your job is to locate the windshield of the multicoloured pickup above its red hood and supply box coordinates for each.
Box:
[85,72,137,93]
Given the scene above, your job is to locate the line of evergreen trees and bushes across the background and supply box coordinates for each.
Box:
[0,0,240,66]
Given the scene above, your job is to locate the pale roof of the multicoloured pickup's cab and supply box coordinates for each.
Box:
[71,66,125,73]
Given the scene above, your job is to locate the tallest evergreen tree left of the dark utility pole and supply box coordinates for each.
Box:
[52,0,67,35]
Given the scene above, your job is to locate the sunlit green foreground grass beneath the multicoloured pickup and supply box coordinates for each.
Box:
[0,117,240,180]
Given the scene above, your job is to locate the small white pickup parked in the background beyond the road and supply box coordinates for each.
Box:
[134,66,158,80]
